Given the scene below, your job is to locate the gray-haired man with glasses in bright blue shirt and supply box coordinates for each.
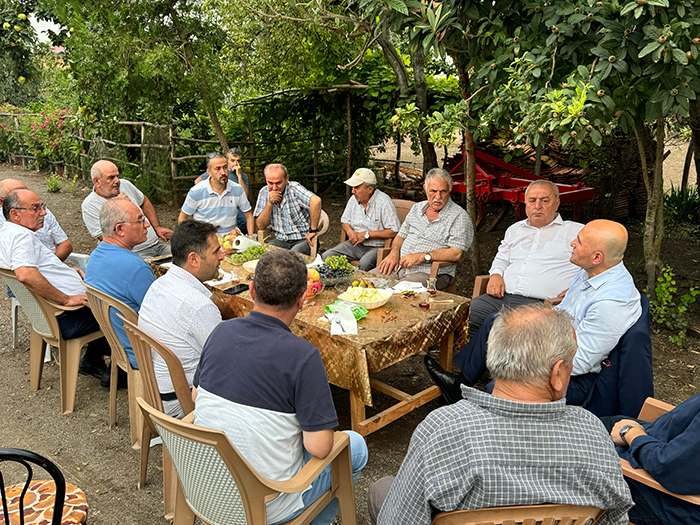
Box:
[85,199,156,376]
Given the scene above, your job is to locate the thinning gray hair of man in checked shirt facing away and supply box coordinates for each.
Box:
[486,304,577,387]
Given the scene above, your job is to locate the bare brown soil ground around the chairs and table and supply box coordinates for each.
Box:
[0,148,700,525]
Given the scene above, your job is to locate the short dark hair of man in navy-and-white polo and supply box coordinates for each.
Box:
[253,250,308,311]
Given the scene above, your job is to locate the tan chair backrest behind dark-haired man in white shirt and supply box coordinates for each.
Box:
[118,314,194,420]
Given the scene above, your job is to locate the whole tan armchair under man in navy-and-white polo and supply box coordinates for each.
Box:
[138,398,356,525]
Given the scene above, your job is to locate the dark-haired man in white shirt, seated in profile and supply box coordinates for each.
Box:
[139,220,224,419]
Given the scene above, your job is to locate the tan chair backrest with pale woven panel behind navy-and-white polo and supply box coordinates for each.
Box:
[137,397,278,525]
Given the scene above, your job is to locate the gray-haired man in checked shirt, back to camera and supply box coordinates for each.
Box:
[368,305,632,525]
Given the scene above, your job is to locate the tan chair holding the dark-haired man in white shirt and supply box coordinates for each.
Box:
[119,316,194,519]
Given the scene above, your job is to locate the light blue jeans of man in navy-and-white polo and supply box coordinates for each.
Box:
[277,430,367,525]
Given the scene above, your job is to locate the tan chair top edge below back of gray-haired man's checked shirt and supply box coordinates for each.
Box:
[432,504,605,525]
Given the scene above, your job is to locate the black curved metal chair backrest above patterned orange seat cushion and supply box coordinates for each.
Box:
[0,446,66,525]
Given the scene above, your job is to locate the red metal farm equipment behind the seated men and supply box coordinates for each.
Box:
[450,147,594,232]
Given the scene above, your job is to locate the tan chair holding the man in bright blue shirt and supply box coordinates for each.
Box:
[85,284,148,449]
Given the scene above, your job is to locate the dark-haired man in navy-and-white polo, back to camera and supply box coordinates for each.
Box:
[192,250,367,525]
